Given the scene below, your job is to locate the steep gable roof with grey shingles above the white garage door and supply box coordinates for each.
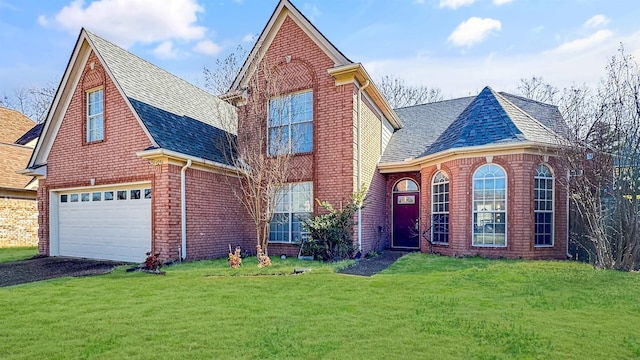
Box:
[28,29,236,169]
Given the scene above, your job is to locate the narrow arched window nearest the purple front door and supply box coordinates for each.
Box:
[431,171,449,244]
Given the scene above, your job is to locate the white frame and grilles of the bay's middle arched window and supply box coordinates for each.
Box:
[471,163,509,248]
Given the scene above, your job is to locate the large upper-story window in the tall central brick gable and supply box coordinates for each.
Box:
[268,90,313,155]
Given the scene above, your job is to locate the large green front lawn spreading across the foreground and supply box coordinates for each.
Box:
[0,253,640,359]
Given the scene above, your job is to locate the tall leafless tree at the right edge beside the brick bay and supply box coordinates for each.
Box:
[560,48,640,271]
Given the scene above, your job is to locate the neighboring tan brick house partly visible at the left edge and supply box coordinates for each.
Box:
[0,107,39,247]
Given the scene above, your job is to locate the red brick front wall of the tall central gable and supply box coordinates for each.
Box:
[239,18,354,256]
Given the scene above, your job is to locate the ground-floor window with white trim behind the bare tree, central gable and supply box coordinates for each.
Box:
[269,182,313,243]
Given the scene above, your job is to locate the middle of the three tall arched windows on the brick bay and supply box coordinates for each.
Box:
[473,164,507,246]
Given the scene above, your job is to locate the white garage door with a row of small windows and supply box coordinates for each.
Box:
[58,184,151,262]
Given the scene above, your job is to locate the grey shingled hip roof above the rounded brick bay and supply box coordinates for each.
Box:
[381,87,563,163]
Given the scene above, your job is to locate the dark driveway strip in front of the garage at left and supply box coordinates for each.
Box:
[0,257,123,287]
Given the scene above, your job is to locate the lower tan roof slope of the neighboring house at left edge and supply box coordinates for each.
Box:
[0,143,33,190]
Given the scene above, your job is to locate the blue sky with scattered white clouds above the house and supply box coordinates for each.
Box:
[0,0,640,98]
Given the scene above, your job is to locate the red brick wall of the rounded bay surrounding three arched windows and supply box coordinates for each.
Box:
[416,154,567,259]
